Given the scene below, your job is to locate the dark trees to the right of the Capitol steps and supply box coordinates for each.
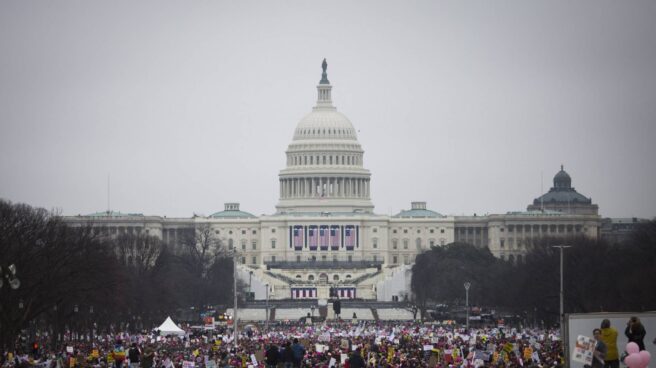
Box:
[411,221,656,324]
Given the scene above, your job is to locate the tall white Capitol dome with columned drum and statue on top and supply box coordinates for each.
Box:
[276,59,374,214]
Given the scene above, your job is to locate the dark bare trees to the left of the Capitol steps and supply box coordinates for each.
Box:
[0,200,240,348]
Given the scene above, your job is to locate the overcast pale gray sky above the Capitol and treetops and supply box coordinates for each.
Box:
[0,0,656,218]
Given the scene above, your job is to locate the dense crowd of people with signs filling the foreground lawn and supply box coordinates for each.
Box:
[0,321,563,368]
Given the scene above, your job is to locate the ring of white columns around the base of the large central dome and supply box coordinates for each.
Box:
[280,177,370,198]
